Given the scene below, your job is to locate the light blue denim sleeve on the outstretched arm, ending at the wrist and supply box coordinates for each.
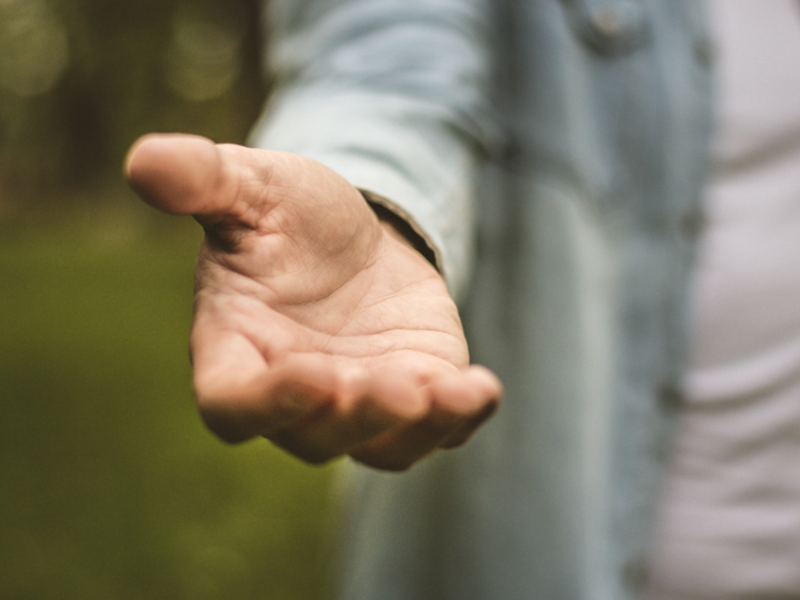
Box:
[251,0,497,296]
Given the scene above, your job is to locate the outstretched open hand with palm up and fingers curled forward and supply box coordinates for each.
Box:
[126,134,501,470]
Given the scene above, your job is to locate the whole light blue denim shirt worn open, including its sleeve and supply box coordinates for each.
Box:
[252,0,711,600]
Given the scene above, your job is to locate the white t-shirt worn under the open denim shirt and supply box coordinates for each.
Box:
[650,0,800,600]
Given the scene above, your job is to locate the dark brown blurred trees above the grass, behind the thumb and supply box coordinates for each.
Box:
[0,0,266,205]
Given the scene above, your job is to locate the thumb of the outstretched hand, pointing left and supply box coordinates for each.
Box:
[124,133,250,221]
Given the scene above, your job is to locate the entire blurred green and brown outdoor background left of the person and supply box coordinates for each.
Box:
[0,0,335,600]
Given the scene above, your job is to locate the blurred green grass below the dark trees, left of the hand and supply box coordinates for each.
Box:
[0,196,332,600]
